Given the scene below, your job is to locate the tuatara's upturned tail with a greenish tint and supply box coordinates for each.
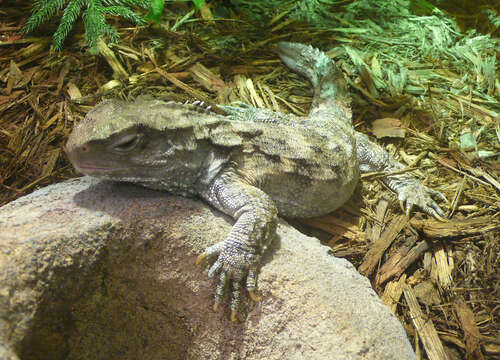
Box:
[278,42,350,121]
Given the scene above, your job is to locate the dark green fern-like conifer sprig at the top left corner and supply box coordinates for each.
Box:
[23,0,152,53]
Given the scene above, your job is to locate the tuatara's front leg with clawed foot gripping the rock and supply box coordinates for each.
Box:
[197,169,278,321]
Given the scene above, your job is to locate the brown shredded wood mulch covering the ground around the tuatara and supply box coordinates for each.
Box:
[0,2,500,359]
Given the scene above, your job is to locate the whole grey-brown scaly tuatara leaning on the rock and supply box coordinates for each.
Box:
[66,43,445,320]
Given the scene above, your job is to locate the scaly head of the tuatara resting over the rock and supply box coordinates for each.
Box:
[66,100,222,189]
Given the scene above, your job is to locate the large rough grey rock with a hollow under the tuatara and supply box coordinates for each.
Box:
[0,178,415,360]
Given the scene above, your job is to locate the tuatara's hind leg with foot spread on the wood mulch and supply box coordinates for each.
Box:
[355,133,447,221]
